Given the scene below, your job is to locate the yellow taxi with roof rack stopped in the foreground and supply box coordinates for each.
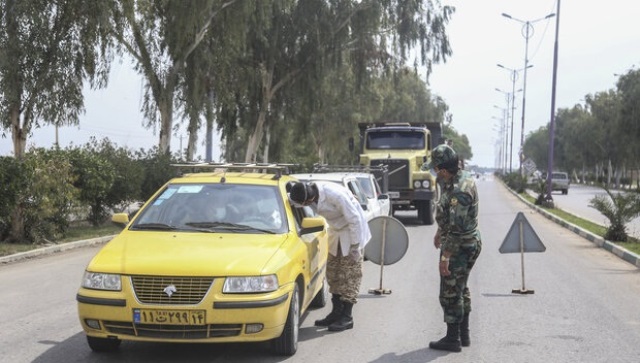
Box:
[76,163,328,355]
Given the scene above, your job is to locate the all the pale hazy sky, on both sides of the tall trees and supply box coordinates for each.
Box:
[0,0,640,169]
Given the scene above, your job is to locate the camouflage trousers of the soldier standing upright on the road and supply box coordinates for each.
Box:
[440,240,482,323]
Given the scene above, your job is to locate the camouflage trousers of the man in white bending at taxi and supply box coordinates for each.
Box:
[327,249,362,304]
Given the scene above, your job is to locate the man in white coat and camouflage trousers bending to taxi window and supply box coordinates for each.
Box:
[289,182,371,331]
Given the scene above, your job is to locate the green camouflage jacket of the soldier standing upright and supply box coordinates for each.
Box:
[436,170,480,254]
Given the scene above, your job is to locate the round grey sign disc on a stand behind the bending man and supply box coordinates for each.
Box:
[364,216,409,265]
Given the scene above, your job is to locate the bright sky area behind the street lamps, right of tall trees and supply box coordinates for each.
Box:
[429,0,640,169]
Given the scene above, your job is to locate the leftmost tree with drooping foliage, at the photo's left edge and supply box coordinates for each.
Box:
[0,0,114,159]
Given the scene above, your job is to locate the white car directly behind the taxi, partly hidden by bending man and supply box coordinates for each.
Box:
[292,172,391,221]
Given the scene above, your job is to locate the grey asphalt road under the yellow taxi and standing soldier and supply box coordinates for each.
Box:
[0,180,640,363]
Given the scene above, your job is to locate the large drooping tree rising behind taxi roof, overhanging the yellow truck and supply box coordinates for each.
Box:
[225,0,453,162]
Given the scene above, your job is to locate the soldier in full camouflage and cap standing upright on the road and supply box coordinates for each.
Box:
[422,145,482,352]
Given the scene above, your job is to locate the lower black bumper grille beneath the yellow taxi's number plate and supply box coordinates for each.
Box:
[102,321,242,339]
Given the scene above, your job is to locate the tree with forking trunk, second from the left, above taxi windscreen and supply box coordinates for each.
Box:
[114,0,237,153]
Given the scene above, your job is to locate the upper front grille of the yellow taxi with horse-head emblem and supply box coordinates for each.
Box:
[131,276,213,305]
